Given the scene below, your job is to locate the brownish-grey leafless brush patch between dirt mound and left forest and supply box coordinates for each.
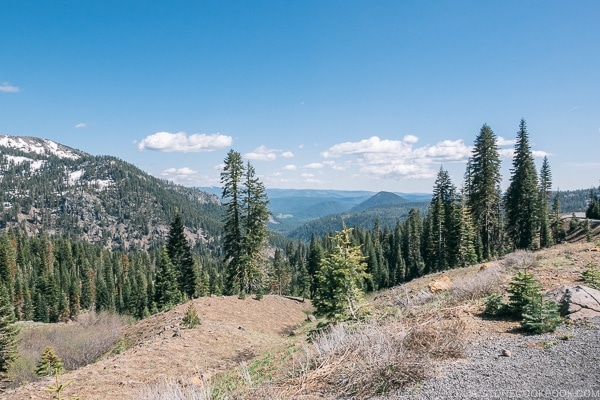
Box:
[10,313,128,386]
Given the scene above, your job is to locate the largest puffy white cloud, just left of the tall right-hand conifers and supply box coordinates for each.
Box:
[321,135,471,179]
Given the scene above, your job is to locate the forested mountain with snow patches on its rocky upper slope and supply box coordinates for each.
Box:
[0,135,222,252]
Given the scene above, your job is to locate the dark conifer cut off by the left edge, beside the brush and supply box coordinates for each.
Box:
[0,284,19,387]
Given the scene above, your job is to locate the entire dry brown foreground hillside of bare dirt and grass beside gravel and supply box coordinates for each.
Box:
[0,242,598,400]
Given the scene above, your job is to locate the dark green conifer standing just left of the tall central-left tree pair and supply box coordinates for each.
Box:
[167,212,198,298]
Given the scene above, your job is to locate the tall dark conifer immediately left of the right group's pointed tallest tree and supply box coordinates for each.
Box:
[465,124,502,260]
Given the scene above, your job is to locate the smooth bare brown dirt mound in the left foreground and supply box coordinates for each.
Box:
[0,296,311,400]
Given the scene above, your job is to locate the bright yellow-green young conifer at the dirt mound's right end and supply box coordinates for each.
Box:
[313,228,368,321]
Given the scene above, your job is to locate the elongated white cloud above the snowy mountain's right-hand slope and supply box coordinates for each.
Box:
[138,132,233,153]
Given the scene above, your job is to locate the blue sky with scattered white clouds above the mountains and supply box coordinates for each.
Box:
[0,0,600,192]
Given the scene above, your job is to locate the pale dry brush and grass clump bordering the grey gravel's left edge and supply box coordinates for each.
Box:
[284,319,465,398]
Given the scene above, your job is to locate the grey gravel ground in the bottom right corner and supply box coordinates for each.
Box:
[385,318,600,400]
